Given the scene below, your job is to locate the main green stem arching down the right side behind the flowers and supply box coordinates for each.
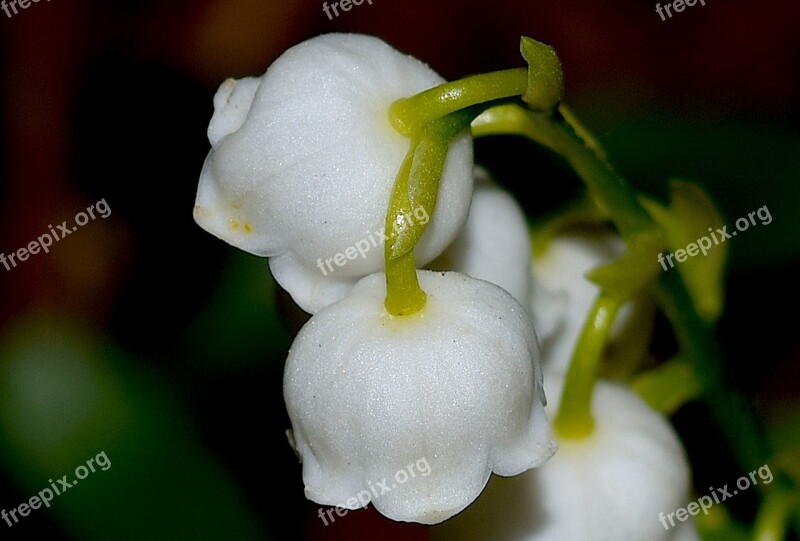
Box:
[472,101,770,471]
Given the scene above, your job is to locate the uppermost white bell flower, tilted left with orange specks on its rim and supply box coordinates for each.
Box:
[194,34,472,313]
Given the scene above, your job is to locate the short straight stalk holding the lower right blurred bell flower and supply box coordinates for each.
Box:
[554,293,621,438]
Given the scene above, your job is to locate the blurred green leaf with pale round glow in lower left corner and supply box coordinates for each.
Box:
[0,318,265,541]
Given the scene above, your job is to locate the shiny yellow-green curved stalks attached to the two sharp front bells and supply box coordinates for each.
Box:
[384,37,563,316]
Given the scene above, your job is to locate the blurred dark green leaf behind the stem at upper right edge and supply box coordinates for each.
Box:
[579,109,800,272]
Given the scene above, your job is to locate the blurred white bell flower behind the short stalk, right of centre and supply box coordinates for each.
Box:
[530,229,647,374]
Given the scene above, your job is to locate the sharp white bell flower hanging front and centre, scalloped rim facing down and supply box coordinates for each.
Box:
[284,271,555,524]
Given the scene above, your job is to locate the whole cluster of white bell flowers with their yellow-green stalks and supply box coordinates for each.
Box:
[194,29,704,540]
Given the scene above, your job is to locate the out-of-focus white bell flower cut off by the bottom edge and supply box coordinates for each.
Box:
[432,372,698,541]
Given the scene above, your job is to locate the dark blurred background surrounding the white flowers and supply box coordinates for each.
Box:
[0,0,800,540]
